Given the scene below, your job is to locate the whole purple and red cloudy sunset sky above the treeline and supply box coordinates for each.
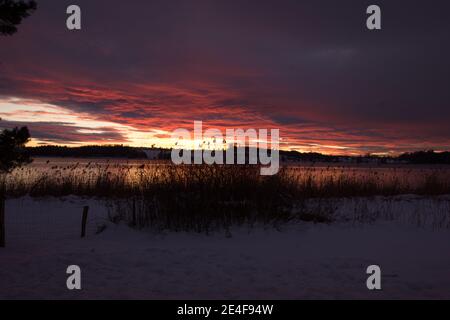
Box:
[0,0,450,154]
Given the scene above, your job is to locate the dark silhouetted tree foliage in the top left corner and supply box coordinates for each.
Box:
[0,0,37,35]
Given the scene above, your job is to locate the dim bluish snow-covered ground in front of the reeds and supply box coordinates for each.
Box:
[0,197,450,299]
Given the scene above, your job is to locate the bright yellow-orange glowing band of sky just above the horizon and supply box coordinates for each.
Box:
[0,97,444,155]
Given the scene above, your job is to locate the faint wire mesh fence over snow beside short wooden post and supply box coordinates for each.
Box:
[5,198,108,246]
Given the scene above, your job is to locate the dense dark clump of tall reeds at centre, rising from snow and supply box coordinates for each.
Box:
[106,166,295,232]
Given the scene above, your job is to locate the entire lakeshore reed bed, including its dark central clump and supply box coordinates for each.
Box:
[5,163,450,232]
